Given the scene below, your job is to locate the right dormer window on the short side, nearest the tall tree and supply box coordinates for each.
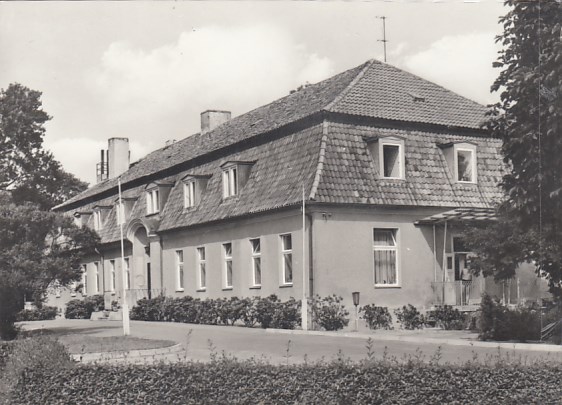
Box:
[438,142,477,183]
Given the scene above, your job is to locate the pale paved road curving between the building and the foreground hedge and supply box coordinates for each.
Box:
[23,320,562,364]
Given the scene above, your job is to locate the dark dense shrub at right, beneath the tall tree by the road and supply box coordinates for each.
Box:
[478,294,541,342]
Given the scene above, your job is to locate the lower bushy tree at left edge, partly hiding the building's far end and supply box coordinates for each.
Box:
[0,196,99,338]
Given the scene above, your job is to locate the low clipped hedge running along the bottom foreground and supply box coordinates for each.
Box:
[12,359,562,404]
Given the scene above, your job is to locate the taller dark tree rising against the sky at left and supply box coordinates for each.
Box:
[0,83,87,209]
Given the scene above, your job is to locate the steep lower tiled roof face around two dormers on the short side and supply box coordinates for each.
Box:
[312,123,503,208]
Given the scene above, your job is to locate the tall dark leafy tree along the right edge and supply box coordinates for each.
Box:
[467,0,562,290]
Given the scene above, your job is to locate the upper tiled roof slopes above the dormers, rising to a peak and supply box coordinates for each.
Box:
[55,60,486,209]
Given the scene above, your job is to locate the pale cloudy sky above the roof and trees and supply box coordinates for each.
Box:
[0,0,507,184]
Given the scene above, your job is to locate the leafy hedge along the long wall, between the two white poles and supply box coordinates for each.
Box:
[131,295,301,329]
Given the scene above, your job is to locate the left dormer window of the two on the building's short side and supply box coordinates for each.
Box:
[366,136,406,179]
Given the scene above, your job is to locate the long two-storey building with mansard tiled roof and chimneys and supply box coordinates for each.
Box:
[51,60,542,316]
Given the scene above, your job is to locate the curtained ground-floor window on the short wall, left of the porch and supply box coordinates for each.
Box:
[373,229,398,286]
